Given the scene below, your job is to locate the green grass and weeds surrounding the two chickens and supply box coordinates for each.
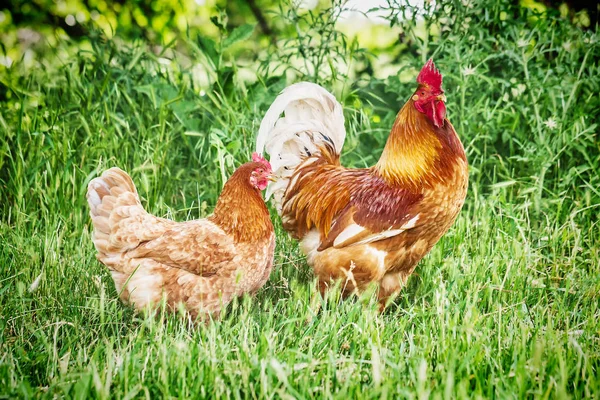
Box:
[0,2,600,398]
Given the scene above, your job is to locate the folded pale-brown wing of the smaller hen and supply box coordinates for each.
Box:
[128,219,237,276]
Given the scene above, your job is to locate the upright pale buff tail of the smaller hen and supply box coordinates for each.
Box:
[86,168,172,268]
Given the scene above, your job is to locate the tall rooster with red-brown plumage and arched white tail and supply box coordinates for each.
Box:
[256,60,468,310]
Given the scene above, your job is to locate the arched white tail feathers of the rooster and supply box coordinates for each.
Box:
[256,82,346,210]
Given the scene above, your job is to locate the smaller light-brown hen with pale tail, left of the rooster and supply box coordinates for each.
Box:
[87,154,275,319]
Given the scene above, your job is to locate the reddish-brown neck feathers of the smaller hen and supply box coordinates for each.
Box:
[209,163,273,242]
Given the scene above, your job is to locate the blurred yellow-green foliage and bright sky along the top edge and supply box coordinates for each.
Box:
[0,0,598,76]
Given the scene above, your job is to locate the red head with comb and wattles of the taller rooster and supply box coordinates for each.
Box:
[412,59,446,128]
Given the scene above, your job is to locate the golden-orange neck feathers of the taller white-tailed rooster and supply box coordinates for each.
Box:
[375,100,466,191]
